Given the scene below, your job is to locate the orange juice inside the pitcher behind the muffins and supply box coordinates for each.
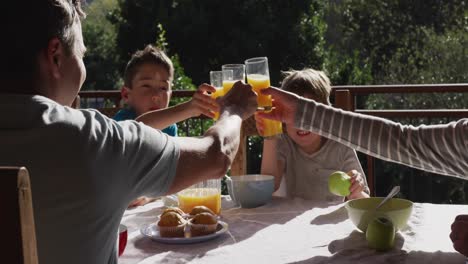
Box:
[177,188,221,214]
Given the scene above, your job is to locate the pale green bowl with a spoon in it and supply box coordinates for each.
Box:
[345,197,413,232]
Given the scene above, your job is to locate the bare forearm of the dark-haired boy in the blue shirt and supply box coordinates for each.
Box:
[136,102,192,129]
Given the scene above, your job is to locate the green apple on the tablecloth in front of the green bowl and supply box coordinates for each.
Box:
[366,217,396,251]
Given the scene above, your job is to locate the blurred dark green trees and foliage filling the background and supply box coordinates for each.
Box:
[83,0,468,203]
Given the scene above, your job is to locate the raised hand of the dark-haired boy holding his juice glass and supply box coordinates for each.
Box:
[189,84,219,118]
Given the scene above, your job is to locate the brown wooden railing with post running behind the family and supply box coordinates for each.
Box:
[79,83,468,197]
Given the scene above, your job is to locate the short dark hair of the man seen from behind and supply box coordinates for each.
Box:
[0,0,85,89]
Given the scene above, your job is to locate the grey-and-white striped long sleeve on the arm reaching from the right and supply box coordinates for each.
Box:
[294,99,468,179]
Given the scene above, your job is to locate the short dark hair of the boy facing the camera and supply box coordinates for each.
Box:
[124,45,174,89]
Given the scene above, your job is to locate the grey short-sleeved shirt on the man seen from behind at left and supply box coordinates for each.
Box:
[0,95,178,263]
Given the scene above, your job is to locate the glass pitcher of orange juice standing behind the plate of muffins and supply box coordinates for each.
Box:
[177,179,221,215]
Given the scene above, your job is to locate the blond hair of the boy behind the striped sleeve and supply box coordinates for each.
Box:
[281,68,331,105]
